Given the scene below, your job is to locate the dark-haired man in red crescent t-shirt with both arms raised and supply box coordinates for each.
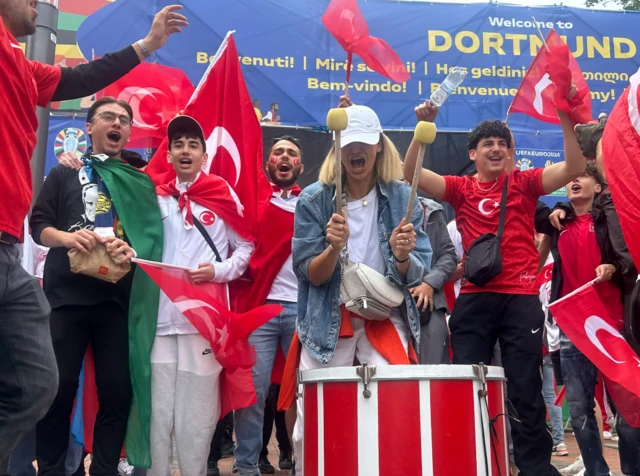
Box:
[404,101,585,476]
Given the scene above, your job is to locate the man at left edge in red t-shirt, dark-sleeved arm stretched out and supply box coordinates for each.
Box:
[0,0,187,464]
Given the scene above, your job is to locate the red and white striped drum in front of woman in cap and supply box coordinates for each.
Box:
[299,365,509,476]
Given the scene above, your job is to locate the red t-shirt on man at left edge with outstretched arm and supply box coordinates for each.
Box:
[0,18,62,237]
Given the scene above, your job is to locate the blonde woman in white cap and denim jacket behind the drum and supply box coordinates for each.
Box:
[293,106,431,474]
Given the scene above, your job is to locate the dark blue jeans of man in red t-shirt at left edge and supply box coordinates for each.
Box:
[0,243,58,472]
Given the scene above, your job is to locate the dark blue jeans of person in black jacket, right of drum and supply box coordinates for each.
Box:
[560,334,609,476]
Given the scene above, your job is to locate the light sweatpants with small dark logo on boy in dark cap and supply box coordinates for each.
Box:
[148,334,222,476]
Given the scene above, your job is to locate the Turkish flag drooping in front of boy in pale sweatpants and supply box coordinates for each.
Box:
[134,258,282,416]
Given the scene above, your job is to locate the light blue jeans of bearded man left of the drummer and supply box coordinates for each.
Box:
[234,301,298,476]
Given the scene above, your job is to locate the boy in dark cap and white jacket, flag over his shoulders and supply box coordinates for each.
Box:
[147,116,254,476]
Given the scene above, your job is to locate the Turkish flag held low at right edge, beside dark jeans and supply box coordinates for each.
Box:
[549,282,640,403]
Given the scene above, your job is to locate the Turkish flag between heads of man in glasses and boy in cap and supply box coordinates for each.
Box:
[96,63,194,148]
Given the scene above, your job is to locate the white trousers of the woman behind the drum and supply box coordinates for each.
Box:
[292,316,409,476]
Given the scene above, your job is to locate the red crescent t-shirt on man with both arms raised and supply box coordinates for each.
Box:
[444,169,544,295]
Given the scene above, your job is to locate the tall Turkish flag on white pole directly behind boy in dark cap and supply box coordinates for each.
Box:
[146,33,271,236]
